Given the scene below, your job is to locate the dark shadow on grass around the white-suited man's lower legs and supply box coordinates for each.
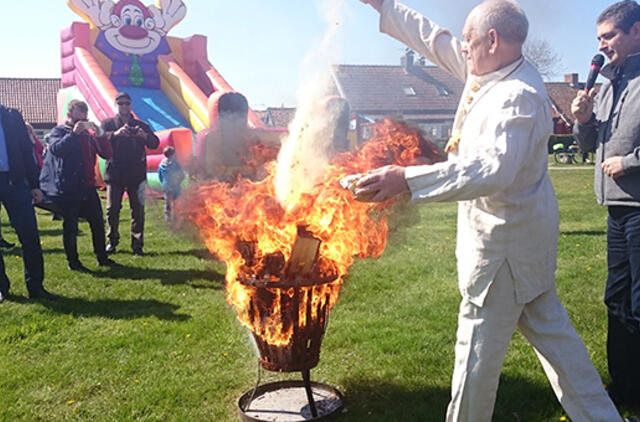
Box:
[340,369,562,422]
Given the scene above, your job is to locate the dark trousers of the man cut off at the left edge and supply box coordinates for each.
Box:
[0,172,44,293]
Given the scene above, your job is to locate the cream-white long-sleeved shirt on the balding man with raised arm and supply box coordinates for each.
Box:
[380,0,558,306]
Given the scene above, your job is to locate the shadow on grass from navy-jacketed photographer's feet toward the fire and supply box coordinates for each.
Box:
[92,265,224,290]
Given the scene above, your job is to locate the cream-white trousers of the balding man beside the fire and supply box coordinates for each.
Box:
[446,262,622,422]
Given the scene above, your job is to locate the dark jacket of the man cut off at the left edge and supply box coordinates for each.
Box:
[0,105,39,189]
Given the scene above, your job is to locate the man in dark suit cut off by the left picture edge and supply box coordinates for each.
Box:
[0,105,58,302]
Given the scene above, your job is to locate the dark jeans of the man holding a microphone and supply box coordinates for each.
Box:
[604,206,640,404]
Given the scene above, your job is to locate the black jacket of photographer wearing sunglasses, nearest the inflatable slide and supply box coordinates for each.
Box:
[102,116,160,186]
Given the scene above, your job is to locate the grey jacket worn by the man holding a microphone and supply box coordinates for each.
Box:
[573,54,640,207]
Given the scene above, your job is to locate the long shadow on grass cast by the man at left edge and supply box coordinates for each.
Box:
[11,296,191,321]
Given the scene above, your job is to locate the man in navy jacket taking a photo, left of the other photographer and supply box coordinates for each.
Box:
[40,100,115,271]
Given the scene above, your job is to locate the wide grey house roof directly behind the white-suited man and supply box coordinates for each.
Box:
[333,64,464,119]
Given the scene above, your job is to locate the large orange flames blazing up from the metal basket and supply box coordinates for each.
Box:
[178,120,442,346]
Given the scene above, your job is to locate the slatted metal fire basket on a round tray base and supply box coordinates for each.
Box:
[238,227,343,421]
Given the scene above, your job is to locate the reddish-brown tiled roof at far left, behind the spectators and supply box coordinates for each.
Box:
[0,78,60,125]
